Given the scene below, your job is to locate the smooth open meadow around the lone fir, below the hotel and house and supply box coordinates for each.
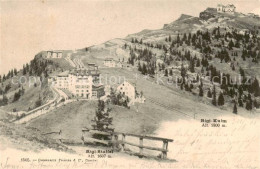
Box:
[28,66,258,142]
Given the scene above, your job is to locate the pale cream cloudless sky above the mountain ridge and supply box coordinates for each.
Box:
[0,0,260,74]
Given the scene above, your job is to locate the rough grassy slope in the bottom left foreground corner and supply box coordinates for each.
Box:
[0,110,73,152]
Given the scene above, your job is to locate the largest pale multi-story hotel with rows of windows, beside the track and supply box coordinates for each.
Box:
[51,69,104,99]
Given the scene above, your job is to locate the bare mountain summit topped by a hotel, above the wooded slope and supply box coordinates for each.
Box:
[127,4,260,41]
